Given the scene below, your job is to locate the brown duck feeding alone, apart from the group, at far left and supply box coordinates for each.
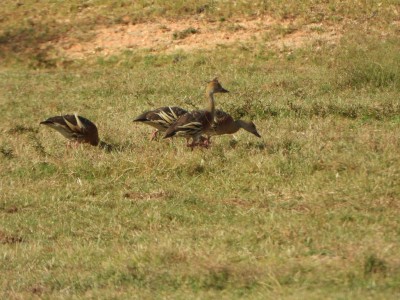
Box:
[40,113,112,150]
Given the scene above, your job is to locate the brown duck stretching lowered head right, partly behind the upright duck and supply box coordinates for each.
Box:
[202,109,261,147]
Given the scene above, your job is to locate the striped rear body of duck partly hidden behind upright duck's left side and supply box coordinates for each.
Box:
[133,106,188,141]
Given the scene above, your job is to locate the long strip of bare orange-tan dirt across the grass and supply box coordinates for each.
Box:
[55,17,341,59]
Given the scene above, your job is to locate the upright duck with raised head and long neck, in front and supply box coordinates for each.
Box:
[163,78,229,150]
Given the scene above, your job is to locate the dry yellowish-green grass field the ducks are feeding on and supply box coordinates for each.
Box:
[0,1,400,299]
